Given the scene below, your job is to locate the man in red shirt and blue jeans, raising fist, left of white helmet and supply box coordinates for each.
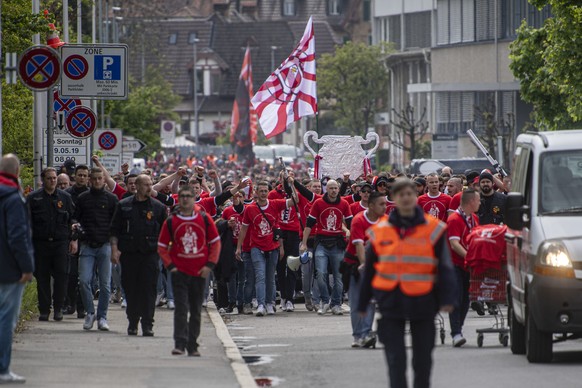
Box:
[236,177,297,317]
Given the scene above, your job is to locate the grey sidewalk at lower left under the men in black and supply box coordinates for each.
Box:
[11,304,246,388]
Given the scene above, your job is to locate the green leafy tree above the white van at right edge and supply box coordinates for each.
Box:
[510,0,582,129]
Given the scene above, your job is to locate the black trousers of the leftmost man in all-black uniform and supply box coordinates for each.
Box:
[33,241,69,314]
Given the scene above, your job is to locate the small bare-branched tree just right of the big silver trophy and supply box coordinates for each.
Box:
[388,104,430,160]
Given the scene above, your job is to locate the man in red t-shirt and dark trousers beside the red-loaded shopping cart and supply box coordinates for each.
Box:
[447,189,481,347]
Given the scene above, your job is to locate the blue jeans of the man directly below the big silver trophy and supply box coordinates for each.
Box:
[314,244,344,307]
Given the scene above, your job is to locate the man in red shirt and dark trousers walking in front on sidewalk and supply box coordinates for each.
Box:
[158,186,220,357]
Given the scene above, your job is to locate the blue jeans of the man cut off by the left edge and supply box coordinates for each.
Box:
[0,283,24,374]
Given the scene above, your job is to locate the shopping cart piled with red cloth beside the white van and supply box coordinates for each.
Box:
[466,225,509,347]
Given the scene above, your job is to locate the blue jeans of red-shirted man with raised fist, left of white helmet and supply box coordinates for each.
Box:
[251,248,279,306]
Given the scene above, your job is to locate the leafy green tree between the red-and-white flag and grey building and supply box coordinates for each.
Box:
[317,42,388,136]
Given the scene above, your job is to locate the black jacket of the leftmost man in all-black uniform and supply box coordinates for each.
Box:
[26,188,75,242]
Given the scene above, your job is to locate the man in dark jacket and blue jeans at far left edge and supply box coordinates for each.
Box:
[0,154,34,384]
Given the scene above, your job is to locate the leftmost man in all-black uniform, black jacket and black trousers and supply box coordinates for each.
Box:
[27,167,77,321]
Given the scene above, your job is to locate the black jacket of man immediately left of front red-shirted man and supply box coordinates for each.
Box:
[111,195,167,255]
